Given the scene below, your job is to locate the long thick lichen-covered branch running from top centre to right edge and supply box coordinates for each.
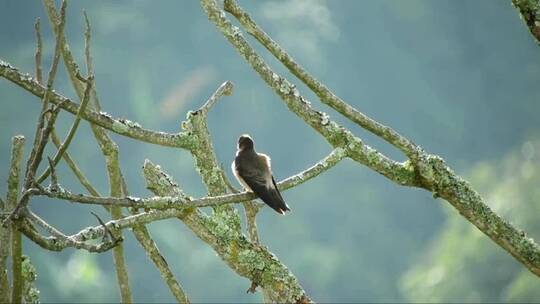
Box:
[201,0,540,276]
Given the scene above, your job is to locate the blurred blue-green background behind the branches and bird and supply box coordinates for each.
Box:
[0,0,540,302]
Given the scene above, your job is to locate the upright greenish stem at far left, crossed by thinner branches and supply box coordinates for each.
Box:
[6,135,24,303]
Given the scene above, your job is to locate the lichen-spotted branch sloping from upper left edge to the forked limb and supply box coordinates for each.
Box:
[0,59,193,149]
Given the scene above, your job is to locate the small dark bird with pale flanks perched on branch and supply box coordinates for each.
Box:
[231,134,291,214]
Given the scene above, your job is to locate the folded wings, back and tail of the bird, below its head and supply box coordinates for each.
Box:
[237,154,290,214]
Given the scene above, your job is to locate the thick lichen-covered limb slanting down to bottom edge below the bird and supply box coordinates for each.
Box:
[143,161,309,303]
